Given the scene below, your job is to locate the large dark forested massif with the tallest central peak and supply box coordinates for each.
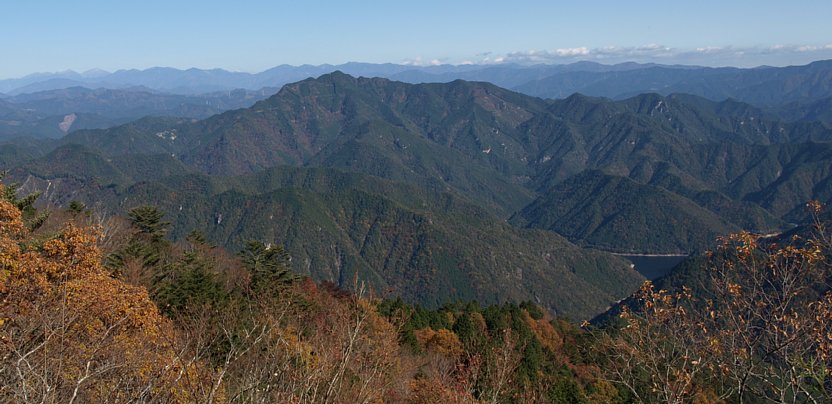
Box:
[39,73,832,243]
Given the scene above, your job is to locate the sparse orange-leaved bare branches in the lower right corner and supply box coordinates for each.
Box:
[601,202,832,403]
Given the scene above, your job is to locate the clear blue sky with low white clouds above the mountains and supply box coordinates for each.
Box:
[0,0,832,78]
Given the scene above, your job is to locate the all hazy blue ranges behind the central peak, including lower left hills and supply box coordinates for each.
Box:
[0,61,832,145]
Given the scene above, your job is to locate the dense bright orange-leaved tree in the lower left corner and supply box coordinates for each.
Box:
[0,185,201,402]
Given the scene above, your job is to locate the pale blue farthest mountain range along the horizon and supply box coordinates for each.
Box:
[0,61,832,107]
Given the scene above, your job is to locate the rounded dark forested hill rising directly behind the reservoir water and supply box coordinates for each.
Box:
[513,170,739,253]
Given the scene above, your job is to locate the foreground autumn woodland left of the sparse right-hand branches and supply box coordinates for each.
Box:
[0,185,597,403]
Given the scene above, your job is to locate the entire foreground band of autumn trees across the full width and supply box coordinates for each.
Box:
[0,175,832,403]
